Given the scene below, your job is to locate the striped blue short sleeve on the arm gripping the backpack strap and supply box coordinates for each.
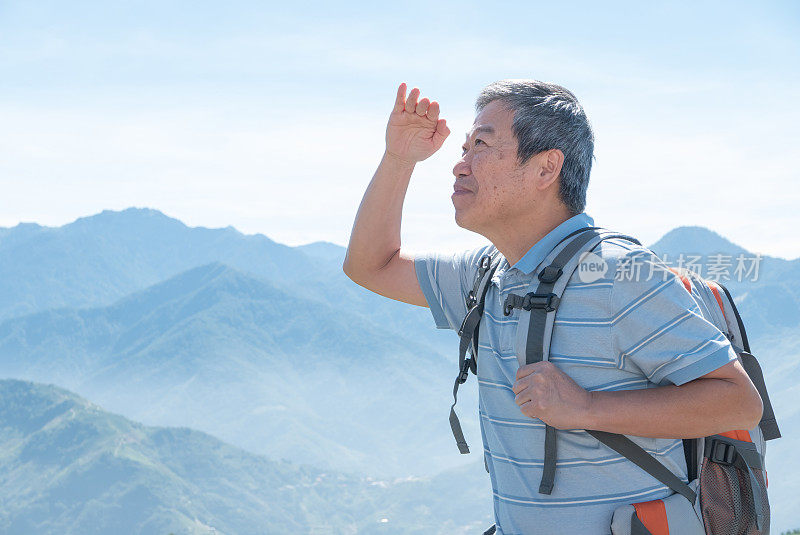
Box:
[610,249,737,385]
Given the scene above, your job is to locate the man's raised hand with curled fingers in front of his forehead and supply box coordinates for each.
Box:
[386,82,450,164]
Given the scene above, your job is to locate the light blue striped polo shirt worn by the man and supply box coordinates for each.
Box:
[414,213,736,535]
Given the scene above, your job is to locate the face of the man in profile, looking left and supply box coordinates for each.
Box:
[451,100,536,236]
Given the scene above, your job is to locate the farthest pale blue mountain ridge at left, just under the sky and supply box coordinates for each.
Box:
[0,207,324,319]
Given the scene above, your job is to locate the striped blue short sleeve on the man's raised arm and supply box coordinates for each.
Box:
[414,245,492,331]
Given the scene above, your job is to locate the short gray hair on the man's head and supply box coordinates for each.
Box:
[475,80,594,214]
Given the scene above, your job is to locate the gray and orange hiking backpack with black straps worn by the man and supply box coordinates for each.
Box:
[450,227,781,535]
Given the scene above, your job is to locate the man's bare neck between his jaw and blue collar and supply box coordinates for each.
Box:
[485,202,575,266]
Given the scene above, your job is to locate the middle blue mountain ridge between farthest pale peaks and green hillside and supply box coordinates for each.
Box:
[0,263,468,475]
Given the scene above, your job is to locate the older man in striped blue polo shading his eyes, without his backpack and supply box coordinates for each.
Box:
[343,80,762,534]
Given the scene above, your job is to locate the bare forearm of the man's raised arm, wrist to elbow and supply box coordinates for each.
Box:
[343,153,414,278]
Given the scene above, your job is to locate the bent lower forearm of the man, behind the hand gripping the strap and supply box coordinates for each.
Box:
[585,378,761,438]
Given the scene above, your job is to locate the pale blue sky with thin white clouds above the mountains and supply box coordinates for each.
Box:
[0,0,800,258]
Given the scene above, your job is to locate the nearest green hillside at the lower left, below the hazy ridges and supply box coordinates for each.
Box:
[0,380,491,535]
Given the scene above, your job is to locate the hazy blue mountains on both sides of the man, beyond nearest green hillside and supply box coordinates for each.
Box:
[0,209,800,532]
